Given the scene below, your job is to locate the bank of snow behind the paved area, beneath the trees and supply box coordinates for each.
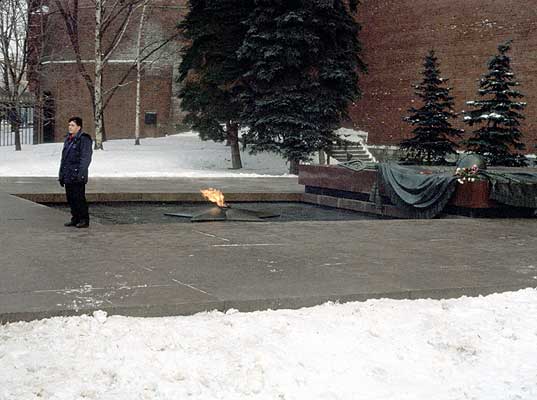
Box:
[0,132,289,178]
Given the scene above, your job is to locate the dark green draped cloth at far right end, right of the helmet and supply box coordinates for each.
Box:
[481,171,537,208]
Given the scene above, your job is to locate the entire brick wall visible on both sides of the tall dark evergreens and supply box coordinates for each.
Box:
[32,0,537,152]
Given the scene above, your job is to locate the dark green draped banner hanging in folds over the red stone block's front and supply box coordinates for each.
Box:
[372,163,457,218]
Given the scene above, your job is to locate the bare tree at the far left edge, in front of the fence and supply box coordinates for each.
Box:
[0,0,43,151]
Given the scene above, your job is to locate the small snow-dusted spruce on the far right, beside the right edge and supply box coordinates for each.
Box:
[464,42,526,166]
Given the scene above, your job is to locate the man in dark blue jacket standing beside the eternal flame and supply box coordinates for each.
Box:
[59,117,93,228]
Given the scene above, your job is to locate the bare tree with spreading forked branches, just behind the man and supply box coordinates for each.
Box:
[54,0,177,149]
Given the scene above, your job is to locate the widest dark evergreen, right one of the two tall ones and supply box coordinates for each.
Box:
[239,0,365,173]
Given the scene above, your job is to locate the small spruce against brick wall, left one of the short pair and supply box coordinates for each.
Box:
[401,50,462,164]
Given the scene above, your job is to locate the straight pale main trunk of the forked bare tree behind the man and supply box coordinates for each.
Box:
[94,0,103,150]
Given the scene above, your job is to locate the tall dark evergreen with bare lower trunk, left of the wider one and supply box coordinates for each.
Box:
[179,0,253,169]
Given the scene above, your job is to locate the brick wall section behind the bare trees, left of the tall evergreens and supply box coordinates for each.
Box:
[39,0,186,141]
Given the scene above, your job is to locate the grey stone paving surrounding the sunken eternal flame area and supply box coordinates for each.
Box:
[0,178,537,322]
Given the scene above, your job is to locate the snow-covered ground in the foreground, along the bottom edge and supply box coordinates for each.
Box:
[0,289,537,400]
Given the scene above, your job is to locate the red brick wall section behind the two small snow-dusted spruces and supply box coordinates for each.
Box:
[351,0,537,152]
